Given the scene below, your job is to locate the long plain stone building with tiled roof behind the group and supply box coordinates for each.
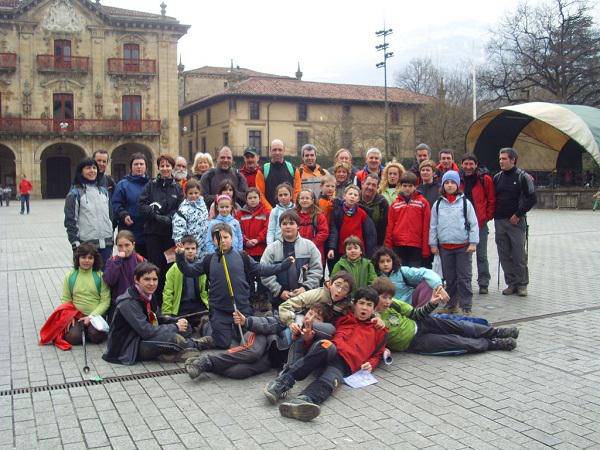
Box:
[179,64,432,162]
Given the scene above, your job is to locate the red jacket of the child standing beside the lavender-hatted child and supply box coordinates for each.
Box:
[385,191,431,258]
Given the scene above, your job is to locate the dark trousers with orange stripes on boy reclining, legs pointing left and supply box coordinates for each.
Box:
[208,332,271,380]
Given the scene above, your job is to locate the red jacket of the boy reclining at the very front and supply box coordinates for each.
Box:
[332,312,388,373]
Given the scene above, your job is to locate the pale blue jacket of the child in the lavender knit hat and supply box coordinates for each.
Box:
[429,193,479,247]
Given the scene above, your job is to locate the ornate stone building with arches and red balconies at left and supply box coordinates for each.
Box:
[0,0,188,198]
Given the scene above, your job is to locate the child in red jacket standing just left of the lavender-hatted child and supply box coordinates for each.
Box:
[385,171,431,267]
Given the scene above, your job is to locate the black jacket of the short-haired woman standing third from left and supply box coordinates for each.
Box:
[138,175,183,238]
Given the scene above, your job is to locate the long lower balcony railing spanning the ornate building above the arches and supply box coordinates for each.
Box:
[0,117,160,135]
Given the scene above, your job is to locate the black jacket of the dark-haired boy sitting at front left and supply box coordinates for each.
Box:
[102,287,178,365]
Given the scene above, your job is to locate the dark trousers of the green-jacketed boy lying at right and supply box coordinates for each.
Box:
[408,317,496,353]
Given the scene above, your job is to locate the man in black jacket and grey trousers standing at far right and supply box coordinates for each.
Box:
[494,147,536,297]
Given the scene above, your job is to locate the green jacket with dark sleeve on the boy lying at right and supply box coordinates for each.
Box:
[379,299,437,352]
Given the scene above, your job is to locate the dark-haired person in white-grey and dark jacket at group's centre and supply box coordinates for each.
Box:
[260,210,323,308]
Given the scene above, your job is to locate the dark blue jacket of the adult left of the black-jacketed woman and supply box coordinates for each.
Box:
[112,175,148,243]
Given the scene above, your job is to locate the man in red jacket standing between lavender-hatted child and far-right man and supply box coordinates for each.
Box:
[460,153,496,294]
